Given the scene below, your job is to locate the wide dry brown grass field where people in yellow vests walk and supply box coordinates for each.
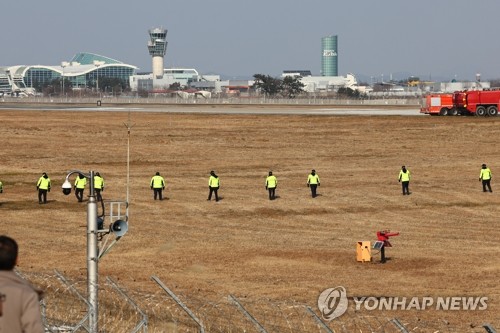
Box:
[0,105,500,332]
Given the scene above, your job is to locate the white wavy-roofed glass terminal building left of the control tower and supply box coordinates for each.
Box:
[0,53,138,95]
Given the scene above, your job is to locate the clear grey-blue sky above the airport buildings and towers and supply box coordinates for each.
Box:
[0,0,500,80]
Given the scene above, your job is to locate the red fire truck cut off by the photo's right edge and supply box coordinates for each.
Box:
[453,90,500,117]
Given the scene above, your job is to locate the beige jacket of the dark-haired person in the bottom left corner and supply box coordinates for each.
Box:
[0,271,44,333]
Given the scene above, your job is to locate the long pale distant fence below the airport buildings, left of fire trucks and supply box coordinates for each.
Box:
[0,96,421,107]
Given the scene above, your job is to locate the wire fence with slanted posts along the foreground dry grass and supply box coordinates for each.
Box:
[19,271,468,333]
